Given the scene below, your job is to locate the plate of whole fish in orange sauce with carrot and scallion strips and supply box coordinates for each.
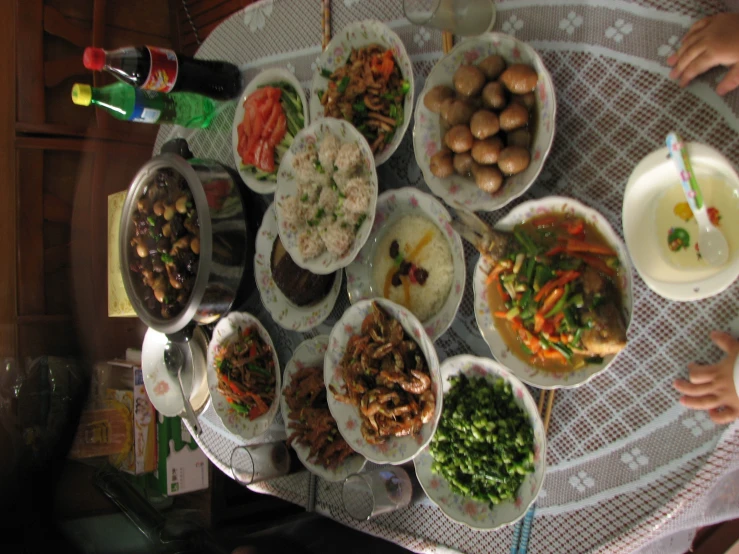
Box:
[452,196,633,388]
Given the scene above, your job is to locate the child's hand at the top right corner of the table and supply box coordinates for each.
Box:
[667,13,739,96]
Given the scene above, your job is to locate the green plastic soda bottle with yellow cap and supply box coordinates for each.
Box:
[72,82,216,129]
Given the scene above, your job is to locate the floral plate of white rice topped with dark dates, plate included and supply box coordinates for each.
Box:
[346,187,466,341]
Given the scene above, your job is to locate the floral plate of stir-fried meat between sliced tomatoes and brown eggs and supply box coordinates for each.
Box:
[309,21,413,165]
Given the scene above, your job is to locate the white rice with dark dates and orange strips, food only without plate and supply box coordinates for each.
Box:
[373,215,454,322]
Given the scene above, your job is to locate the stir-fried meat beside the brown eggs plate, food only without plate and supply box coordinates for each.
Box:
[318,44,410,153]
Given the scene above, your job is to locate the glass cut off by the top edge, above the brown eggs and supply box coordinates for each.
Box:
[403,0,495,37]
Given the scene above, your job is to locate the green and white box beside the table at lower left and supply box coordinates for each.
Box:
[155,414,209,496]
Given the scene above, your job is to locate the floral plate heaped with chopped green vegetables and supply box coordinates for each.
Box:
[413,355,546,530]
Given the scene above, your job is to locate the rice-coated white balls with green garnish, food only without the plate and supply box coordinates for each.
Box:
[278,133,374,260]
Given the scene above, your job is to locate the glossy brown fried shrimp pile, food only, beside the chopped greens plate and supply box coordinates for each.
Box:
[329,302,436,444]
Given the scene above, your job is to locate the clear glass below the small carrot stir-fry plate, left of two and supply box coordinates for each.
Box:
[231,442,290,485]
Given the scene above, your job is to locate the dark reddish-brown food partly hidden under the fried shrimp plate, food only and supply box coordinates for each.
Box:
[285,367,354,469]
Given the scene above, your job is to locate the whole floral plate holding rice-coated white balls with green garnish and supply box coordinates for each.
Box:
[275,118,378,275]
